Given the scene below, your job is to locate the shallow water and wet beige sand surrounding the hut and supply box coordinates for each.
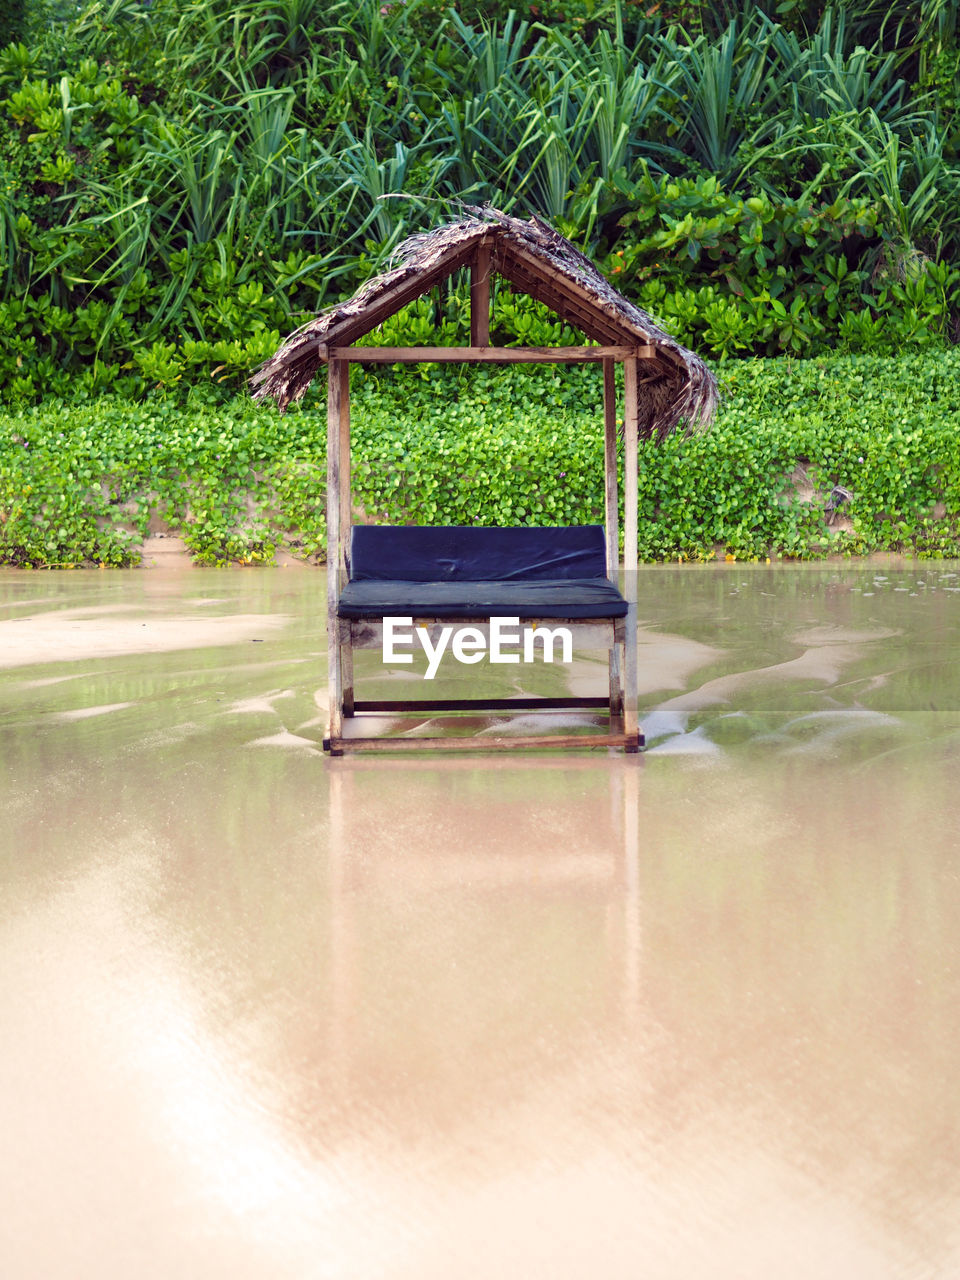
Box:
[0,564,960,1280]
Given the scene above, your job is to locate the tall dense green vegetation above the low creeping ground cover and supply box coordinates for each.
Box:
[0,0,960,404]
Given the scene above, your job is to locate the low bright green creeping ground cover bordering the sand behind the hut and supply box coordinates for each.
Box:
[0,348,960,567]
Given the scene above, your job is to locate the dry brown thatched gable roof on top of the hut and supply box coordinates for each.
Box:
[251,207,717,438]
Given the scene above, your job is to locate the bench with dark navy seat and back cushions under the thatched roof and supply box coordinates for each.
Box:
[328,525,640,754]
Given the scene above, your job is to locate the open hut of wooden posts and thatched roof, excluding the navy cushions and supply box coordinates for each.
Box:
[252,209,716,753]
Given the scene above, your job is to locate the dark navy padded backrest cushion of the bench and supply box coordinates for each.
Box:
[351,525,607,582]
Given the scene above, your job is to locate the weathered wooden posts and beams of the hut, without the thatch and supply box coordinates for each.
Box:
[320,241,654,755]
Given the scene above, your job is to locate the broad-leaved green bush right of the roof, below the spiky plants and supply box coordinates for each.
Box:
[602,174,960,357]
